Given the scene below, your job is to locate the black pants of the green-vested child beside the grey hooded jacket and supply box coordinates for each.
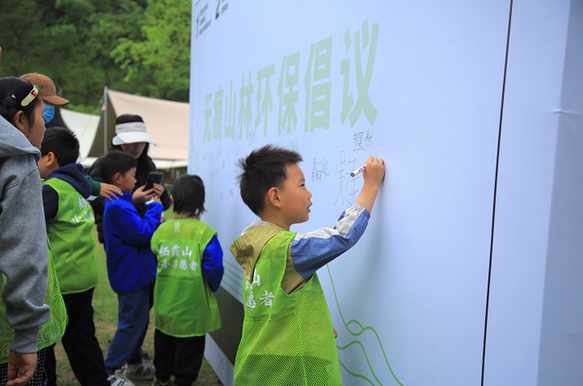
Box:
[45,289,110,386]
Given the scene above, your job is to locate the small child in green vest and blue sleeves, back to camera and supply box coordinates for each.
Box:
[152,175,224,386]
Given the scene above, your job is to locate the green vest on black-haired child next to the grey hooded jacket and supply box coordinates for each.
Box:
[45,178,99,294]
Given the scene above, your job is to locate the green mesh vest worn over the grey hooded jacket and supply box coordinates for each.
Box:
[0,249,67,364]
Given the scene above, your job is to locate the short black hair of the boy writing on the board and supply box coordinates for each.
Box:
[237,145,303,216]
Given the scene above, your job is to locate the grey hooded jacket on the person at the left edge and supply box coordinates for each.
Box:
[0,117,50,353]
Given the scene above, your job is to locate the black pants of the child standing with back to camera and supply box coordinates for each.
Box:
[154,329,205,386]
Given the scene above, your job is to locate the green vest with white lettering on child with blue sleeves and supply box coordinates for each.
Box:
[152,219,221,338]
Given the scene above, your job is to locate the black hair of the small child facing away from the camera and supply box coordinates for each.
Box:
[170,174,205,217]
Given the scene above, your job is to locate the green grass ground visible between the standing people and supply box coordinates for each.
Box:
[55,226,222,386]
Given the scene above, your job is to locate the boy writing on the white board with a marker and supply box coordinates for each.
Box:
[230,145,385,386]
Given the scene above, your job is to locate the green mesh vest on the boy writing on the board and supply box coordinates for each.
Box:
[234,231,342,386]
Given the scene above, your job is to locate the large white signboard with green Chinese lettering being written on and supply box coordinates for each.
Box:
[189,0,580,385]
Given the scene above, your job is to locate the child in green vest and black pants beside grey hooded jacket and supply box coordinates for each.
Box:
[38,127,128,386]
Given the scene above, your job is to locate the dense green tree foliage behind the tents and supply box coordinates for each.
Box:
[0,0,191,112]
